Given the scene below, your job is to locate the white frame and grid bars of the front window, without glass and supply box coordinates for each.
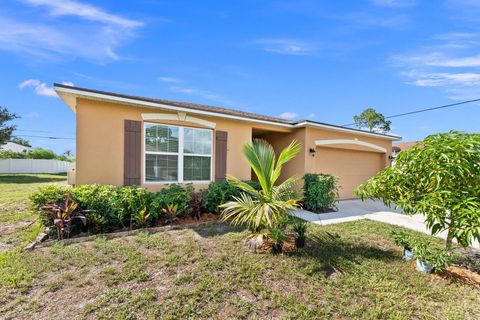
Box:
[142,122,214,185]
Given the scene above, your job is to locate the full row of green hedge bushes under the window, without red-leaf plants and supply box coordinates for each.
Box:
[30,181,260,233]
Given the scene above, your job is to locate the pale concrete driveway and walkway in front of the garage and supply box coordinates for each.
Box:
[295,200,480,248]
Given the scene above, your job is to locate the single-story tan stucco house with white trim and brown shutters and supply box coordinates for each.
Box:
[54,84,400,199]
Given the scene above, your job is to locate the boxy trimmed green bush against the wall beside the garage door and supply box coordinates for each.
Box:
[303,173,338,212]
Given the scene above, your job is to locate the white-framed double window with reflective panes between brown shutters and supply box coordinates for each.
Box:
[145,123,213,183]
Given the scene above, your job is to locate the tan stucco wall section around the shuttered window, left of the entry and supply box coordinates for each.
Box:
[76,98,289,191]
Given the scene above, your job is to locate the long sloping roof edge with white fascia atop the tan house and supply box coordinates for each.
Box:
[54,83,401,140]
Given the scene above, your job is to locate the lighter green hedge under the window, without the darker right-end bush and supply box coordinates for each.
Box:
[30,184,193,233]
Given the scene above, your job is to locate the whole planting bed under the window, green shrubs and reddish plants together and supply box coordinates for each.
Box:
[30,181,256,238]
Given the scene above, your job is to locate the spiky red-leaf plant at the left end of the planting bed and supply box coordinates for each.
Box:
[42,193,87,239]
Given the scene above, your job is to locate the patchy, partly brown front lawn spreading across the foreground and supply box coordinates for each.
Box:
[0,220,480,319]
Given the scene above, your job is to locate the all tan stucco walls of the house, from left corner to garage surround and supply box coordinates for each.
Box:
[76,98,392,191]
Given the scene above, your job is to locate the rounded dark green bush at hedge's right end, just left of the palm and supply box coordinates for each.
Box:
[202,180,262,213]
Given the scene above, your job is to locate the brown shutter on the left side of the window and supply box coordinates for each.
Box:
[123,120,142,186]
